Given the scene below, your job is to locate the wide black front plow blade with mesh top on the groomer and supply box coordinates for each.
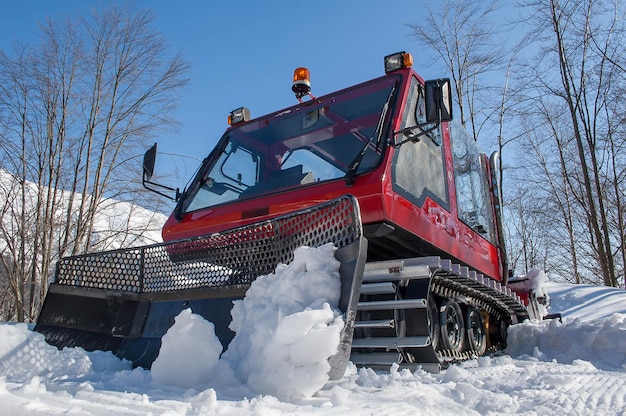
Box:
[35,196,367,378]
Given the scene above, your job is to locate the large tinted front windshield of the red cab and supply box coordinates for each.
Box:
[182,77,398,212]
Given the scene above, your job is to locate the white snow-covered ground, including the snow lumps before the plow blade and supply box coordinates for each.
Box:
[0,248,626,416]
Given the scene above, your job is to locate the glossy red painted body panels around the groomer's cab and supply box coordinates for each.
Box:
[163,69,502,281]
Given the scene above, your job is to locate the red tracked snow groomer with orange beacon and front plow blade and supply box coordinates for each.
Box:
[36,52,540,377]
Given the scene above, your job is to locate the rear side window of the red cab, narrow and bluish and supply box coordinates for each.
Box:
[450,123,494,241]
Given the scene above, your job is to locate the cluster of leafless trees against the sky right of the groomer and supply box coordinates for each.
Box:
[402,0,626,286]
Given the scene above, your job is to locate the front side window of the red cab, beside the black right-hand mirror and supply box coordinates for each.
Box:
[392,78,448,208]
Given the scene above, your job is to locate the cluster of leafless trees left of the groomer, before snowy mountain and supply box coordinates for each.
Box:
[0,4,187,321]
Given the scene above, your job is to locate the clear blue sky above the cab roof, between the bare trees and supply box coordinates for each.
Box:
[0,0,438,187]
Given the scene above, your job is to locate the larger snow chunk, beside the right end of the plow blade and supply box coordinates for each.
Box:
[224,244,344,399]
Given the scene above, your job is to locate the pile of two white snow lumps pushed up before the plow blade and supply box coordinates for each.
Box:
[152,244,344,400]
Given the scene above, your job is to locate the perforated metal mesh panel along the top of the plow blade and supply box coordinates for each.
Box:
[56,196,362,293]
